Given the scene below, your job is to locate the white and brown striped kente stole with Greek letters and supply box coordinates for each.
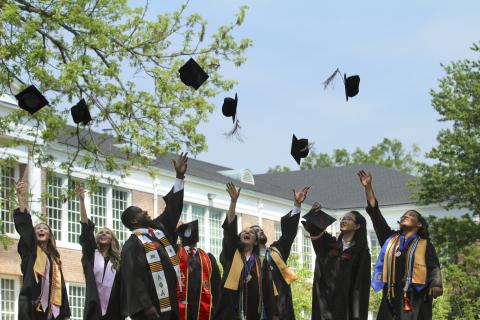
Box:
[132,228,182,312]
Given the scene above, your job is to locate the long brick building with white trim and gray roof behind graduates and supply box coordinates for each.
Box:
[0,92,465,319]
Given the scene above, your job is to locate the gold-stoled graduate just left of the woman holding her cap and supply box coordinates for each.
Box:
[248,187,310,320]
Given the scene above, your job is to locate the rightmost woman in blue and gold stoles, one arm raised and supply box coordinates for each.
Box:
[358,170,443,320]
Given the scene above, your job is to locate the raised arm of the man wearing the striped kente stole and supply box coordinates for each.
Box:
[157,153,188,235]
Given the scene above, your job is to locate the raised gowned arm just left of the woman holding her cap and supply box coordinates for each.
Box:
[271,187,310,261]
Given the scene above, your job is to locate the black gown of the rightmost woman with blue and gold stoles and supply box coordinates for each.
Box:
[366,202,442,320]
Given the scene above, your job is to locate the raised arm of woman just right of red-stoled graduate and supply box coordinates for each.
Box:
[220,182,242,268]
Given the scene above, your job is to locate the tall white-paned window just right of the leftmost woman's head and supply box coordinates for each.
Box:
[47,175,64,241]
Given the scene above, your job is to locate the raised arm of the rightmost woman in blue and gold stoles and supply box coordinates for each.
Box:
[357,170,394,246]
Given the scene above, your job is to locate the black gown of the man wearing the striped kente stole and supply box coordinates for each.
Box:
[120,188,183,320]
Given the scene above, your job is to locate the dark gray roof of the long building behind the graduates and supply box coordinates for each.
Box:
[58,127,417,209]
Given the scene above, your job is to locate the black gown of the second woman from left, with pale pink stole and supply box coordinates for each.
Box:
[80,220,124,320]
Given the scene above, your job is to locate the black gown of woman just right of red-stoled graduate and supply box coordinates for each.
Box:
[214,217,260,320]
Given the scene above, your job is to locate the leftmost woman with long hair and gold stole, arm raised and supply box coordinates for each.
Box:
[13,179,70,320]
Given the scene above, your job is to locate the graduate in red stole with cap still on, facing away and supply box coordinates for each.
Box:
[177,220,220,320]
